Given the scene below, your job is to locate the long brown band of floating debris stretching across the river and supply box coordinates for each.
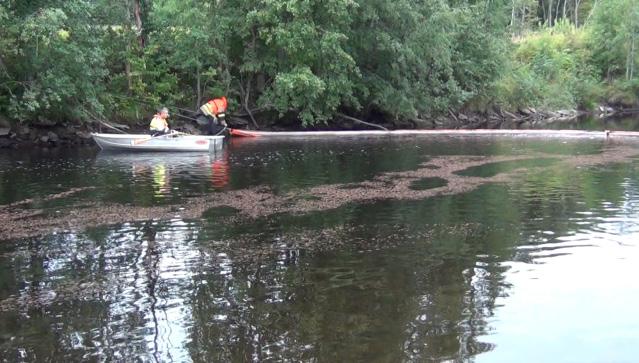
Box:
[0,147,639,240]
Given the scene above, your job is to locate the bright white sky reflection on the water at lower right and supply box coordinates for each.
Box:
[478,188,639,362]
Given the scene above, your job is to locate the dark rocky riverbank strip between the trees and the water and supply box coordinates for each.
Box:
[0,106,639,149]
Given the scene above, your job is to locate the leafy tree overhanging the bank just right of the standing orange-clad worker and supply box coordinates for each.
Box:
[244,0,358,125]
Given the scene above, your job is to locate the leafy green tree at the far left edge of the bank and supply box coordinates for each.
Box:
[0,0,106,121]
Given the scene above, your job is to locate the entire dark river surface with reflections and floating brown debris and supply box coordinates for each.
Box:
[0,125,639,362]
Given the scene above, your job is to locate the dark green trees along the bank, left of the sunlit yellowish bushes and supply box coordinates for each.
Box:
[0,0,507,125]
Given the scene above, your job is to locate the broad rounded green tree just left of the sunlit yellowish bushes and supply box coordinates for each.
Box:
[350,0,505,118]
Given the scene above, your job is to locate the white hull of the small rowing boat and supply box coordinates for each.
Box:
[91,133,224,152]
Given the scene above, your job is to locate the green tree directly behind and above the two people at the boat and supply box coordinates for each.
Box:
[146,0,230,108]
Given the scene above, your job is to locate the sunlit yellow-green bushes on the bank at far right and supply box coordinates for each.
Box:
[496,0,639,109]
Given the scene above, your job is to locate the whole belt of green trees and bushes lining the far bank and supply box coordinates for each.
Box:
[0,0,639,126]
